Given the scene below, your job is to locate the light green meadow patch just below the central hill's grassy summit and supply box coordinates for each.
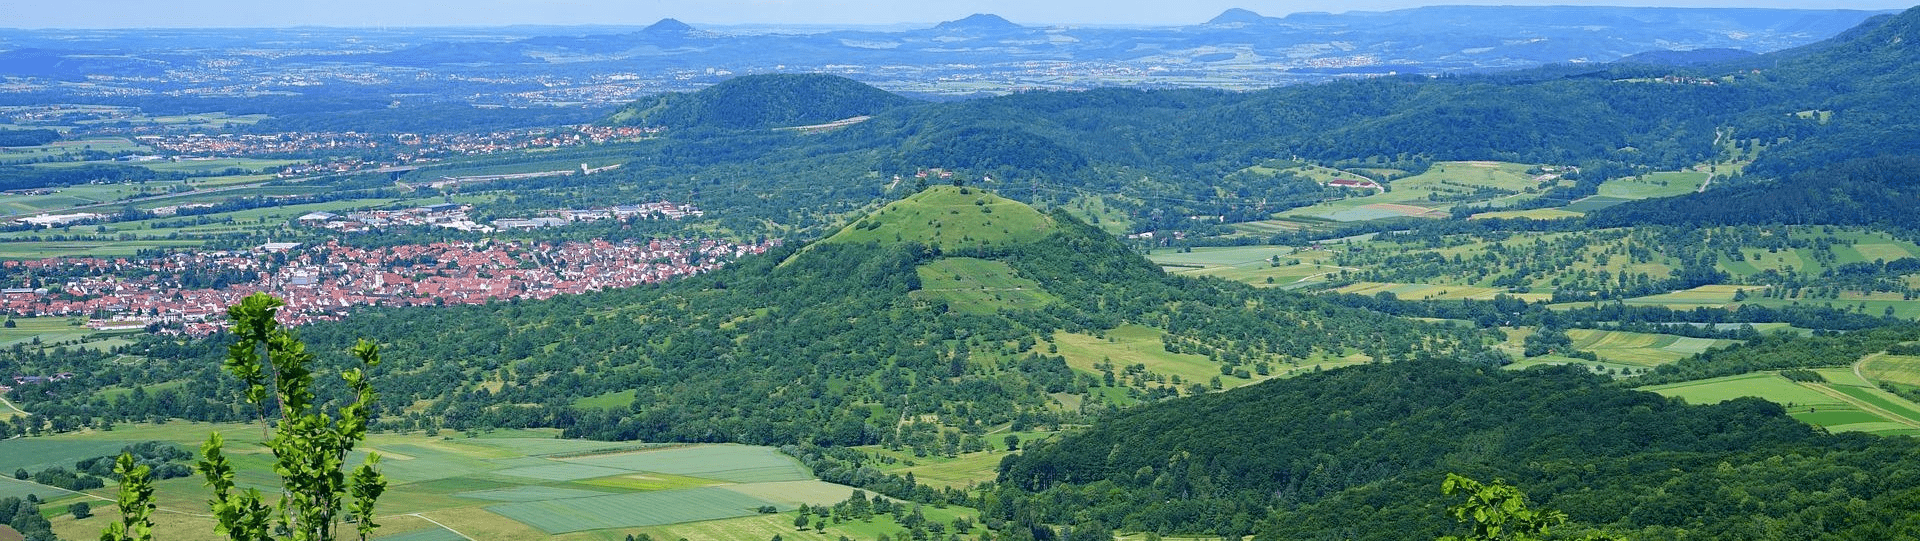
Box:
[914,257,1060,315]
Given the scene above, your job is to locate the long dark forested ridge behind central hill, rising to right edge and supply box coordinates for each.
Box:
[549,13,1920,234]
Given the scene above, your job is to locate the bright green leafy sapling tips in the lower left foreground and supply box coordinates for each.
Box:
[100,294,386,541]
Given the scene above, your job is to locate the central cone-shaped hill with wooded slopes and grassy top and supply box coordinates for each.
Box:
[3,186,1498,445]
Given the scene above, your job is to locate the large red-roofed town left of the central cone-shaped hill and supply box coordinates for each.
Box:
[0,238,780,336]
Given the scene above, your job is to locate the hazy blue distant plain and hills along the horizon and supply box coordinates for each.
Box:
[0,6,1876,104]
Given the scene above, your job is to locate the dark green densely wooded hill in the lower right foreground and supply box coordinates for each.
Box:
[987,359,1920,539]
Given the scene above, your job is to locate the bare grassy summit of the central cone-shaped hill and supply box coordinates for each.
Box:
[822,186,1056,249]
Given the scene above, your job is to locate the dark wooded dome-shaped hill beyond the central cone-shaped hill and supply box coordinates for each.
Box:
[605,73,914,130]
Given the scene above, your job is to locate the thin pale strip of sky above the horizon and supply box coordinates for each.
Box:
[0,0,1920,29]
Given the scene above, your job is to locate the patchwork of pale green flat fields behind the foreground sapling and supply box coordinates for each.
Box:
[20,422,898,541]
